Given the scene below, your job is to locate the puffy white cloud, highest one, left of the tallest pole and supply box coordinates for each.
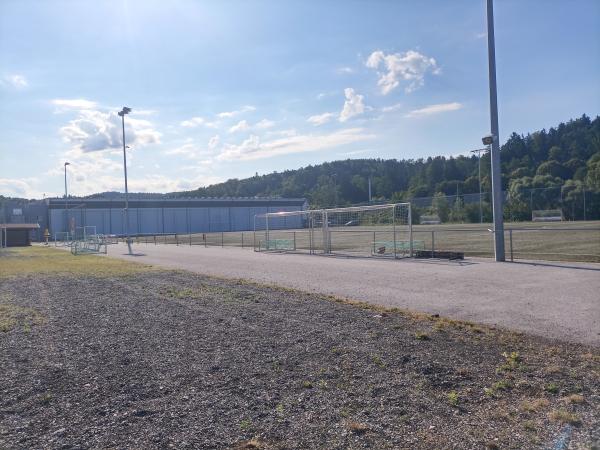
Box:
[366,50,441,95]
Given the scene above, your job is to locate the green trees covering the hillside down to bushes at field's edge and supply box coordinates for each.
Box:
[176,114,600,222]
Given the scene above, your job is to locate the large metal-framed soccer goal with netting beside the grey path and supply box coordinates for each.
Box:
[254,203,414,258]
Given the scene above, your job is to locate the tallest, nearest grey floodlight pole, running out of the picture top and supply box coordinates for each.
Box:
[484,0,505,262]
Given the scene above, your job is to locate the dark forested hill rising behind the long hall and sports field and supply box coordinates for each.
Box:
[177,115,600,212]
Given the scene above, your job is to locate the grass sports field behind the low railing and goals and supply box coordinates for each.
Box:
[132,221,600,262]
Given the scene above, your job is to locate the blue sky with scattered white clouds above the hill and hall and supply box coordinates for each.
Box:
[0,0,600,198]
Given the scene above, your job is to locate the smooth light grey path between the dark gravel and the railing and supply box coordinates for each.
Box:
[104,244,600,345]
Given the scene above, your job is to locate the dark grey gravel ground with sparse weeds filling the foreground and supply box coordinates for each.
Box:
[0,271,600,449]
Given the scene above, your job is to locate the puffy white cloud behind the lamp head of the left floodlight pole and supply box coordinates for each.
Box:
[60,110,161,153]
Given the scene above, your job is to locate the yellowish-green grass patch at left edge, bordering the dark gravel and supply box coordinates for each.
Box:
[0,246,154,278]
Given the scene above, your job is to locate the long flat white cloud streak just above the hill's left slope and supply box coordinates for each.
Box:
[217,128,375,161]
